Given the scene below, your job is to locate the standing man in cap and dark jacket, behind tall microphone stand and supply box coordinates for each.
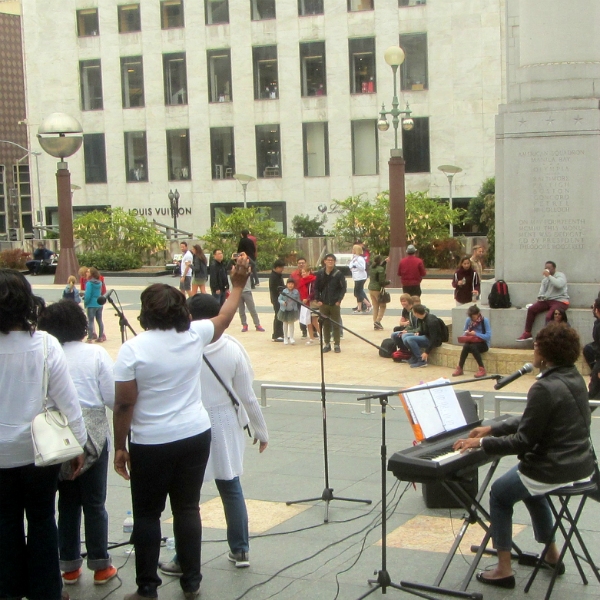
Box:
[315,254,346,352]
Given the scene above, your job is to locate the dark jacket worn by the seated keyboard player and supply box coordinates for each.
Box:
[482,366,594,483]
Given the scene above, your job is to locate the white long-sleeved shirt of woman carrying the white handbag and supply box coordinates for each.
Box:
[0,331,87,468]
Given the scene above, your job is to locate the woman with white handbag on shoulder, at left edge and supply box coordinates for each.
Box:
[0,269,87,600]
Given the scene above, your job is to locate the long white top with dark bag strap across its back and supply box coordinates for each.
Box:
[200,334,269,481]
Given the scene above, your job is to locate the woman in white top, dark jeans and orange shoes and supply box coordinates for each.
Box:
[38,300,117,585]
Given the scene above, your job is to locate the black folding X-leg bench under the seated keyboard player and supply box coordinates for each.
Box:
[525,481,600,600]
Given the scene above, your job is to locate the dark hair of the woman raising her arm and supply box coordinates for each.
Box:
[139,283,190,333]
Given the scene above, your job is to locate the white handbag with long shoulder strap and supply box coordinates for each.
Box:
[31,332,83,467]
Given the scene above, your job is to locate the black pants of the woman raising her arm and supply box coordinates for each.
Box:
[129,429,211,598]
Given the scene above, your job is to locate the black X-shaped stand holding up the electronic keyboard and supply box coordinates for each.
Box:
[400,458,522,593]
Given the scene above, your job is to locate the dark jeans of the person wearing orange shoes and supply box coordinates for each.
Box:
[58,443,111,572]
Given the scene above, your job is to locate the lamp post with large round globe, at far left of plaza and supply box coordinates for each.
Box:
[37,113,83,284]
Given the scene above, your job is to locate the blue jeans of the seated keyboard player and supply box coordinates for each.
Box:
[490,465,554,551]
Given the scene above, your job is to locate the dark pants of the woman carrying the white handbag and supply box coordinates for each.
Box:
[0,464,62,600]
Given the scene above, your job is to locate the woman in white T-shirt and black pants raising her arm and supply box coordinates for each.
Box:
[114,253,249,600]
